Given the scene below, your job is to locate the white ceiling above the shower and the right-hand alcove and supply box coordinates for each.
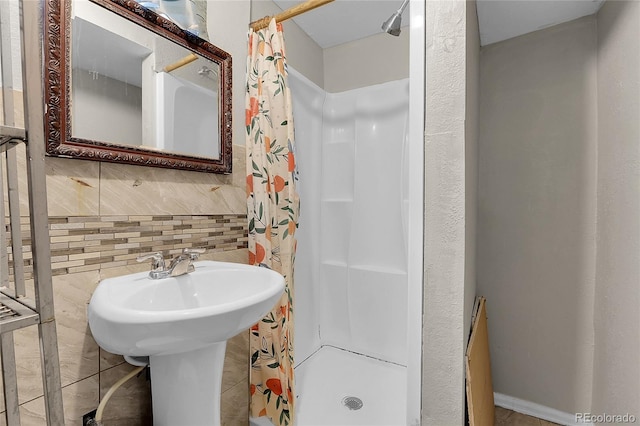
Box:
[274,0,604,48]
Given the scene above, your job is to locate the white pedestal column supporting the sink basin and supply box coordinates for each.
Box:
[149,341,227,426]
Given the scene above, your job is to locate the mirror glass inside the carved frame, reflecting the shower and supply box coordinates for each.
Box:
[71,1,220,159]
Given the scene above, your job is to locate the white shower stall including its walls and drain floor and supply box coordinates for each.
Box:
[289,71,409,426]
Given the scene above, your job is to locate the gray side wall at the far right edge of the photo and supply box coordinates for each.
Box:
[592,1,640,417]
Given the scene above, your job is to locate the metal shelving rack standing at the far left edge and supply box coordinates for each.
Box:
[0,0,64,426]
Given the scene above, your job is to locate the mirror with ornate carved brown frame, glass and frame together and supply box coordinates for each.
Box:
[44,0,232,173]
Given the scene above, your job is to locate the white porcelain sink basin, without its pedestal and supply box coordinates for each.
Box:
[89,261,284,356]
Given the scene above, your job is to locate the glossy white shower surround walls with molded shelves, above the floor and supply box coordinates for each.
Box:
[289,72,409,366]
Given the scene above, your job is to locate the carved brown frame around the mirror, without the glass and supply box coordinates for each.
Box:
[44,0,232,173]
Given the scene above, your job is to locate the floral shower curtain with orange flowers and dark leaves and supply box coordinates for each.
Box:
[245,20,299,425]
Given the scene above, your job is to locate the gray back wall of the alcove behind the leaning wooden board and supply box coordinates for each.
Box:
[477,17,598,413]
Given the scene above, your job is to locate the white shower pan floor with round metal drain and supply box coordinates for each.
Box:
[296,346,407,426]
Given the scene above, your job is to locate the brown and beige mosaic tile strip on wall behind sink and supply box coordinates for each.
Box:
[9,214,247,279]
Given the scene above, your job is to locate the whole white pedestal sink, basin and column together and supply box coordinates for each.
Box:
[89,261,284,426]
